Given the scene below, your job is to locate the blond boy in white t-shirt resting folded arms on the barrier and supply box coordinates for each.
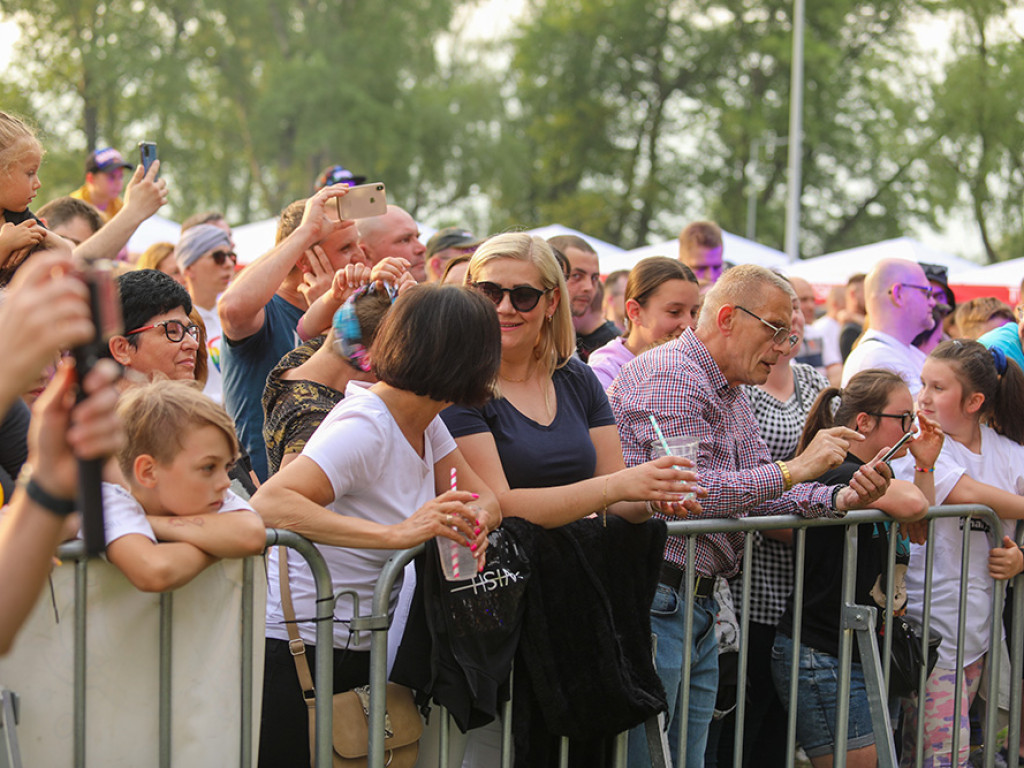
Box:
[91,380,266,592]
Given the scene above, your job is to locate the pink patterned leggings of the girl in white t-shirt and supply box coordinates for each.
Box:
[900,656,985,768]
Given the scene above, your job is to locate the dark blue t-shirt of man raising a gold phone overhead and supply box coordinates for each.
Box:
[220,295,303,482]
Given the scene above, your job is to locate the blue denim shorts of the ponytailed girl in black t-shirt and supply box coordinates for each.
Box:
[771,633,874,758]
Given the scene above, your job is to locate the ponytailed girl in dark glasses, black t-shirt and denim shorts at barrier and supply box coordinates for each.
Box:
[771,369,942,768]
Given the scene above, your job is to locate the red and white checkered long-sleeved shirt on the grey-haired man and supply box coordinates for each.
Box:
[608,330,836,577]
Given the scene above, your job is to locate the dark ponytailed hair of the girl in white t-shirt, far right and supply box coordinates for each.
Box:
[928,339,1024,445]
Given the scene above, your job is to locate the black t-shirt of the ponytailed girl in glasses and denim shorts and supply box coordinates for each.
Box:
[778,454,888,662]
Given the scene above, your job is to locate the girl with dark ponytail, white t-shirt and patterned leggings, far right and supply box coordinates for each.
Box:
[900,340,1024,766]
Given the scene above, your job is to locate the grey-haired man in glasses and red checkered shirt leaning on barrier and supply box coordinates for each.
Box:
[608,265,890,767]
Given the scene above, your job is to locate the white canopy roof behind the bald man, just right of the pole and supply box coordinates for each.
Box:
[786,238,978,286]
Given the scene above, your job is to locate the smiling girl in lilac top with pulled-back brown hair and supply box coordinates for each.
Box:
[587,256,700,389]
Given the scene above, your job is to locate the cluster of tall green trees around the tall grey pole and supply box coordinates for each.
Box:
[507,0,946,256]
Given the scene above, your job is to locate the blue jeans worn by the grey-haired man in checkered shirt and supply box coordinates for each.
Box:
[629,584,718,768]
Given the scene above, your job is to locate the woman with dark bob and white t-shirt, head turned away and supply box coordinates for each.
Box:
[252,285,501,765]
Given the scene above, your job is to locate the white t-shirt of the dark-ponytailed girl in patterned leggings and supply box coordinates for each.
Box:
[894,425,1024,670]
